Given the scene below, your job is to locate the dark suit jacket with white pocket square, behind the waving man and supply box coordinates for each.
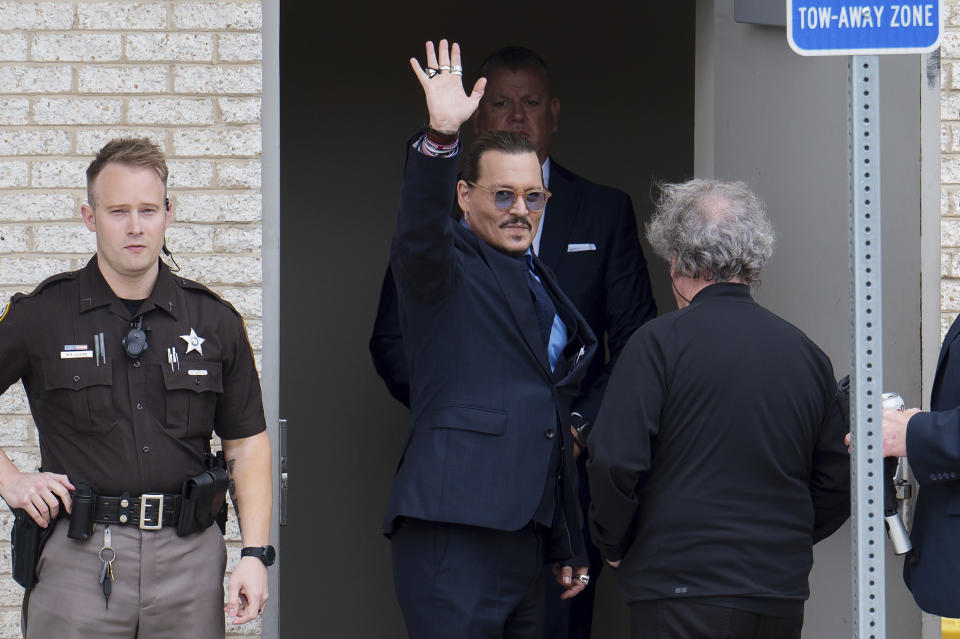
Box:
[370,158,657,420]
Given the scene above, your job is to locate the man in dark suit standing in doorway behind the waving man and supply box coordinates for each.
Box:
[370,46,657,639]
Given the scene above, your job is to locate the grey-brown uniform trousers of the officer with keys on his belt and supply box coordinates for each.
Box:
[21,520,227,639]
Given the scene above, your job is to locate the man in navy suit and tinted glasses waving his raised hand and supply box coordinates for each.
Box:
[384,40,597,639]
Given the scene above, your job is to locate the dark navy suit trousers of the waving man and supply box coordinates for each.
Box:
[390,518,547,639]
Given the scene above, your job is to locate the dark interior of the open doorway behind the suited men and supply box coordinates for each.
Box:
[278,0,694,639]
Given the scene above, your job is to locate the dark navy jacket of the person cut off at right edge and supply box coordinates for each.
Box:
[903,318,960,617]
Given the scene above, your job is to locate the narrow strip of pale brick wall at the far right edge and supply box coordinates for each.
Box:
[940,0,960,339]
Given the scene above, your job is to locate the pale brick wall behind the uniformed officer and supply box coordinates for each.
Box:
[0,0,262,639]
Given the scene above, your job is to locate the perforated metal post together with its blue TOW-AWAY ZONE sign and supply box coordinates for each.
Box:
[786,0,943,639]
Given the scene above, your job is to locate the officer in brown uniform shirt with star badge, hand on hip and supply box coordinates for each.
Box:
[0,139,274,639]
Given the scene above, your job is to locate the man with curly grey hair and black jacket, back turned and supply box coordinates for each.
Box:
[587,180,850,639]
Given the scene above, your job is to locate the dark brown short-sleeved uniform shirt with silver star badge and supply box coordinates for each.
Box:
[0,256,266,495]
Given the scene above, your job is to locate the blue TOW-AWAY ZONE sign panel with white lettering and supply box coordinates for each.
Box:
[787,0,943,55]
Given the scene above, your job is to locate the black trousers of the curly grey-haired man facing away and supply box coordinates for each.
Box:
[630,599,803,639]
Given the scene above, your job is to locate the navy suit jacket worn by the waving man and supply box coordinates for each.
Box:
[384,142,597,561]
